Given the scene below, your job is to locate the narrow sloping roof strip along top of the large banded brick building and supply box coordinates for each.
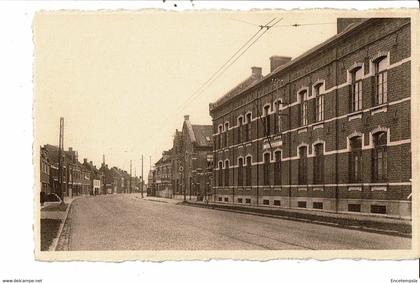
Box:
[210,18,375,111]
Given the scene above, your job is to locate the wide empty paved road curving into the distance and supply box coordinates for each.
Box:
[63,195,411,251]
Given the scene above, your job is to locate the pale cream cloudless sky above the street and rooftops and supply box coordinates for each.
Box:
[33,11,337,175]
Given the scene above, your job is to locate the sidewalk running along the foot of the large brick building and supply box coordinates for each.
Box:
[184,201,412,237]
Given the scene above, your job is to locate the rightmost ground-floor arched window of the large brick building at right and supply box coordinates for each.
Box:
[372,132,388,182]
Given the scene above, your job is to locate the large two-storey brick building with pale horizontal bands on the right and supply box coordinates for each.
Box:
[209,18,411,218]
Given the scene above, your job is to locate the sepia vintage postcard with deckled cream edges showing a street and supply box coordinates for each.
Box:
[33,9,419,261]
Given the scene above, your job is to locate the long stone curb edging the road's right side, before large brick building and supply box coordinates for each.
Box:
[180,202,412,238]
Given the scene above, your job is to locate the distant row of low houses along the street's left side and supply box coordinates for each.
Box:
[40,144,144,200]
